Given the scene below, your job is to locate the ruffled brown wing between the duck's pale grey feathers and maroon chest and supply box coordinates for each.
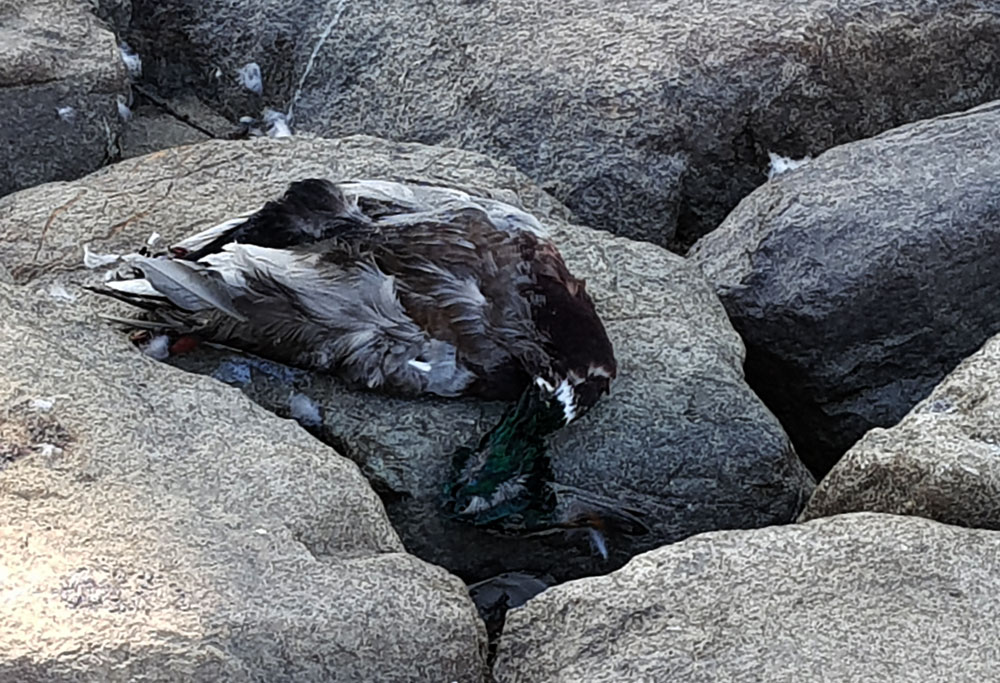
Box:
[373,207,552,399]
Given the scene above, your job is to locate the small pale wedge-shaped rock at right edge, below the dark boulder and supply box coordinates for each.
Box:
[803,337,1000,529]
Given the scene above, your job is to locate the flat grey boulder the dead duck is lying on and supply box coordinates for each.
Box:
[0,137,813,580]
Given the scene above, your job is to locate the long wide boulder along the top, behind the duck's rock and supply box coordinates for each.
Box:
[121,0,1000,244]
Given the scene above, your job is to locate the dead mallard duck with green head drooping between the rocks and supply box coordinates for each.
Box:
[96,178,639,548]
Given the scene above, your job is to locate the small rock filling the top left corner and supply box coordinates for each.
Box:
[0,0,129,195]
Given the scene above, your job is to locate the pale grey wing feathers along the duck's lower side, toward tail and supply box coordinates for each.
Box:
[106,243,475,396]
